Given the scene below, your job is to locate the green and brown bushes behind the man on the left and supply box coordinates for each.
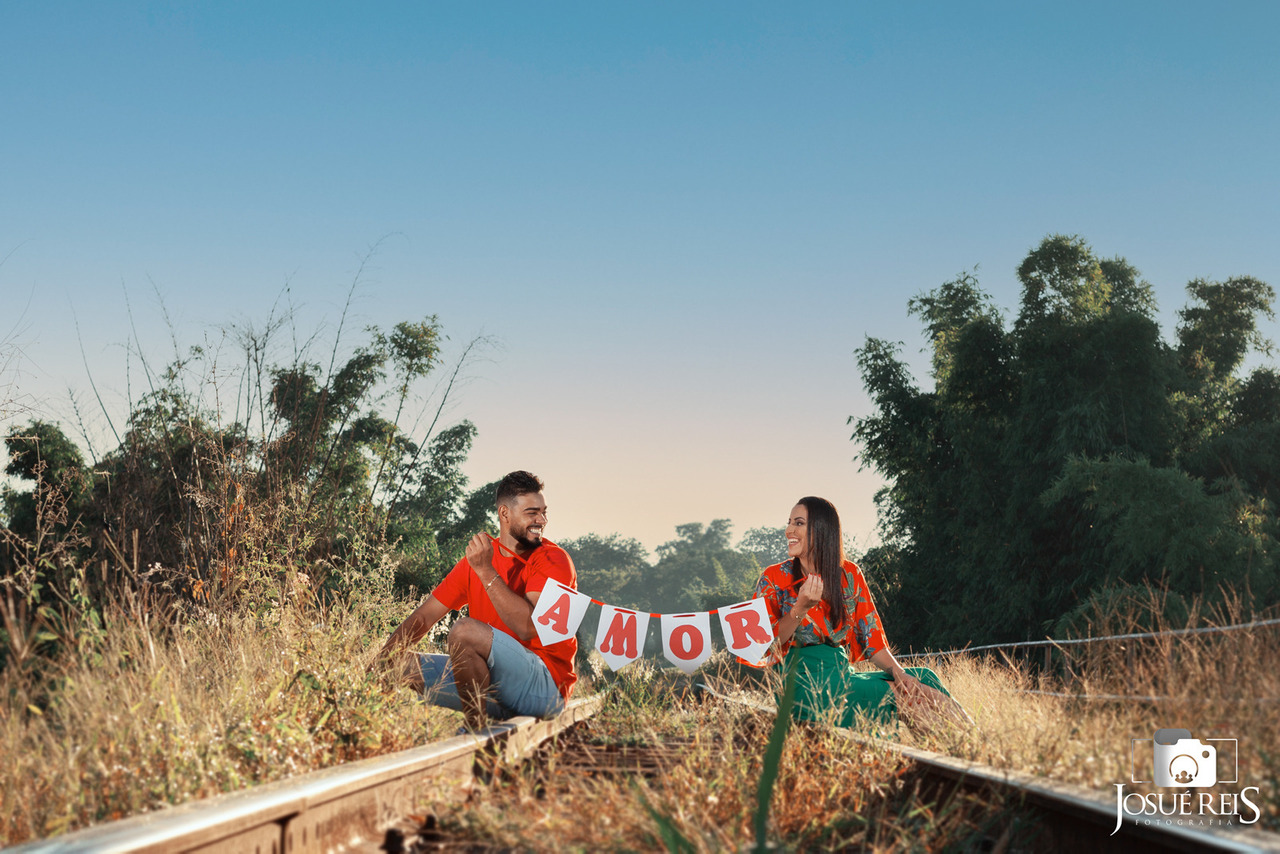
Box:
[0,311,481,617]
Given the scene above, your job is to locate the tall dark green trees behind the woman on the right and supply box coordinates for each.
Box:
[850,236,1280,647]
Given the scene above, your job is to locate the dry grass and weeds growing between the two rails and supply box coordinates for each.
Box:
[419,671,1033,851]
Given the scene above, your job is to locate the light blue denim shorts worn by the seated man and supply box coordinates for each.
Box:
[417,629,564,720]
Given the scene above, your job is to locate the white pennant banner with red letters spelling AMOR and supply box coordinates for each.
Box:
[534,580,773,673]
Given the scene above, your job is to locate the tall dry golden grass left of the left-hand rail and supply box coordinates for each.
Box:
[0,592,460,844]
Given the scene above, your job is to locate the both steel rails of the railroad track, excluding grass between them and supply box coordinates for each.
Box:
[6,685,1280,854]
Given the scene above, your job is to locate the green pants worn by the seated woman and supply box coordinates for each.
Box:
[782,644,951,726]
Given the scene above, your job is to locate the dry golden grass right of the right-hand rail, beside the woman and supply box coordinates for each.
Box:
[918,606,1280,830]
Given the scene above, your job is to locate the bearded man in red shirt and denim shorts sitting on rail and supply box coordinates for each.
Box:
[378,471,577,730]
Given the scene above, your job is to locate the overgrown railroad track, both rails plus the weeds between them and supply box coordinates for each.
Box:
[10,672,1280,854]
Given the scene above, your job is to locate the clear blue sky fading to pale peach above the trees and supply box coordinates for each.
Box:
[0,0,1280,548]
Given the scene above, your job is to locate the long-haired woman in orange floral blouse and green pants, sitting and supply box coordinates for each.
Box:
[755,495,972,726]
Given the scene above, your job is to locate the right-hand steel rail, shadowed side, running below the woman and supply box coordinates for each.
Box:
[699,684,1280,854]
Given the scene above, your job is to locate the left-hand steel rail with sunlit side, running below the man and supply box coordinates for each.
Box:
[4,695,603,854]
